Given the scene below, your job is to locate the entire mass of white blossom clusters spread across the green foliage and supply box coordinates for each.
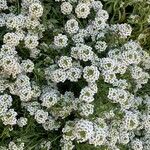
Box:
[0,0,150,150]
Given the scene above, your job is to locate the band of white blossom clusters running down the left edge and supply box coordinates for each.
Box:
[0,0,43,131]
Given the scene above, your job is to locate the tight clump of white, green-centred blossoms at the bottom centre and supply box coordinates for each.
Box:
[62,118,108,147]
